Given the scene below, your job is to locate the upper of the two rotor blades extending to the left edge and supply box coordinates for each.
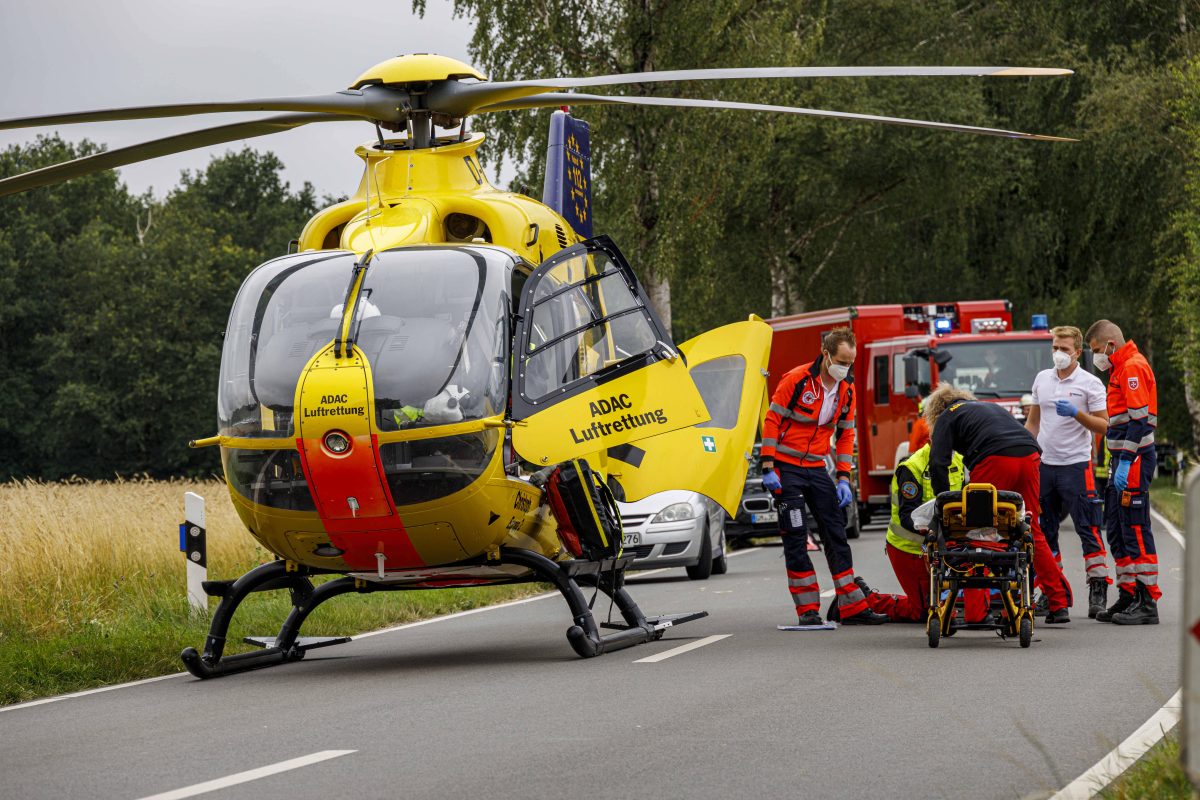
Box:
[0,86,409,131]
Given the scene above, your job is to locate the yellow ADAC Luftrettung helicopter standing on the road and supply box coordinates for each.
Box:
[0,54,1069,678]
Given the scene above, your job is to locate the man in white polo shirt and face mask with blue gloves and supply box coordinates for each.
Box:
[1025,325,1112,619]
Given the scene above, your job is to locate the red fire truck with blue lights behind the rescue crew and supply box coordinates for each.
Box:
[767,300,1051,523]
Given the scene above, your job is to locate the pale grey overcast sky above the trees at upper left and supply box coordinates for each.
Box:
[0,0,504,197]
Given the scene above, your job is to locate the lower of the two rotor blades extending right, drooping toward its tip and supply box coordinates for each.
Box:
[475,92,1078,142]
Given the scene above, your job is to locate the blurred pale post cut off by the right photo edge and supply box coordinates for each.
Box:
[1181,469,1200,789]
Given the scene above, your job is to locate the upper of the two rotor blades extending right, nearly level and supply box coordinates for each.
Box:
[428,67,1073,116]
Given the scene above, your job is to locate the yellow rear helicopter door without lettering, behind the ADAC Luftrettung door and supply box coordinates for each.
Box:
[608,317,772,516]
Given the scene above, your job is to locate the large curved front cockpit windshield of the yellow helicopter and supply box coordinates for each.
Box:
[220,247,514,438]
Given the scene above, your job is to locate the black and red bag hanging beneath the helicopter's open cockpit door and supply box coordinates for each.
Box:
[546,458,622,561]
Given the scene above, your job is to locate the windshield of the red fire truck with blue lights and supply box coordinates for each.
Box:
[937,339,1051,398]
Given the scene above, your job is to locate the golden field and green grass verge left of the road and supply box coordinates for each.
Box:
[0,480,545,704]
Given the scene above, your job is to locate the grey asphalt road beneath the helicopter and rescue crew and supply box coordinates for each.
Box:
[0,515,1183,800]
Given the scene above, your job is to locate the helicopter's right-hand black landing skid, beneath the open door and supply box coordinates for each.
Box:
[500,547,708,658]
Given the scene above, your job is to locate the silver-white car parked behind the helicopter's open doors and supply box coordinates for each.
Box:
[617,489,728,581]
